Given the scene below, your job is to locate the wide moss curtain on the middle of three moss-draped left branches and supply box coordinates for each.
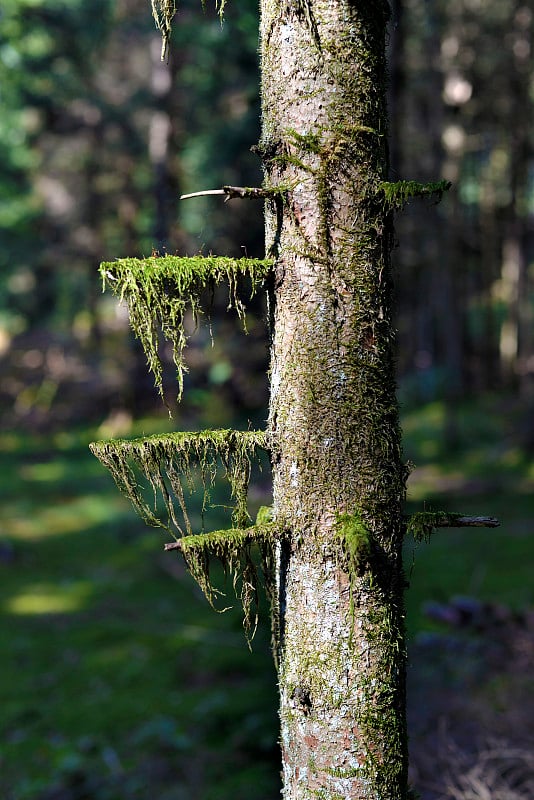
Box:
[90,430,272,539]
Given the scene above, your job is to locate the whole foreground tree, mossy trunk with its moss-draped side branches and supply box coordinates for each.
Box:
[92,0,498,800]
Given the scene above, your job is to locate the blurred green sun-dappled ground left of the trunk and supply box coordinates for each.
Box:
[0,420,279,800]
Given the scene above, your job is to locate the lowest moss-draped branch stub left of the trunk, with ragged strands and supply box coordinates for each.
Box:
[180,523,277,639]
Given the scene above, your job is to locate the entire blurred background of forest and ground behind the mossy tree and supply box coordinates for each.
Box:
[0,0,534,800]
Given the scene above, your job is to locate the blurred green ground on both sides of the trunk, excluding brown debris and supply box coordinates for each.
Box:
[0,401,534,800]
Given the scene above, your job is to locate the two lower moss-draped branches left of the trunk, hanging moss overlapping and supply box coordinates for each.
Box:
[90,430,280,638]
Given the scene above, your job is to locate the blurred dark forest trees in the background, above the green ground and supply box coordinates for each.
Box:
[0,0,534,432]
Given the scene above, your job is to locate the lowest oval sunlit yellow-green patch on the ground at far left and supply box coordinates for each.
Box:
[3,581,93,615]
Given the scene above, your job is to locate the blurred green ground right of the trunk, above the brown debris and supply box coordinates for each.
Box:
[402,396,534,636]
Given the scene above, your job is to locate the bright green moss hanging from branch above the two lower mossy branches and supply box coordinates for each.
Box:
[100,256,273,399]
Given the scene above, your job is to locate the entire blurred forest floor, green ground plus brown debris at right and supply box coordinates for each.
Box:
[0,398,534,800]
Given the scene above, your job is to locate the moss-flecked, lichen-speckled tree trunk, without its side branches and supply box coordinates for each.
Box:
[260,0,407,800]
